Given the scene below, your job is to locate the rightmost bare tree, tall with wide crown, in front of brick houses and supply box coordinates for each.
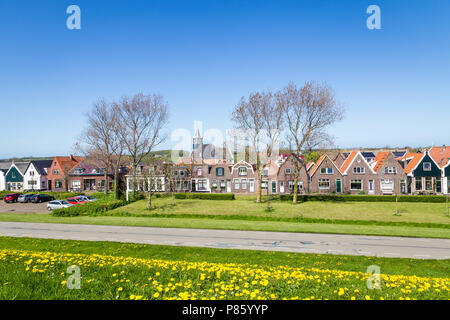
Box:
[277,82,344,203]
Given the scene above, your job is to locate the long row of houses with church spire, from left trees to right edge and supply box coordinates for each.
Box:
[123,130,450,195]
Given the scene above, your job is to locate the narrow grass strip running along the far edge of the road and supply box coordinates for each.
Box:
[0,213,450,239]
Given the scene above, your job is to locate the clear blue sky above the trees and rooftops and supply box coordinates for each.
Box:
[0,0,450,158]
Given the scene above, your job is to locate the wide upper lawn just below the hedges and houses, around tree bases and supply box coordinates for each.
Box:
[111,196,450,225]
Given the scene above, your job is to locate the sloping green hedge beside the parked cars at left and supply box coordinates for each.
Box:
[52,200,129,217]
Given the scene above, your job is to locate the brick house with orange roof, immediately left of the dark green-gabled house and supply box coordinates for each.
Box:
[370,151,408,194]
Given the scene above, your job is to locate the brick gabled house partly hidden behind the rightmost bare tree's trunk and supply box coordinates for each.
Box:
[277,153,312,194]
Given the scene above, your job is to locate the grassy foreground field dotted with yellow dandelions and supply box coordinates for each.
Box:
[0,238,450,300]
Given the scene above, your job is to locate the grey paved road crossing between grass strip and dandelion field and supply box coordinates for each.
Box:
[0,222,450,259]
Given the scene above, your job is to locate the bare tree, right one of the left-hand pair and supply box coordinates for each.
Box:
[114,94,168,201]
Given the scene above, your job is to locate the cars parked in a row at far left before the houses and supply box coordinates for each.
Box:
[3,193,97,211]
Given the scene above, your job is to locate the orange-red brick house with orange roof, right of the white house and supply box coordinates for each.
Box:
[47,155,83,191]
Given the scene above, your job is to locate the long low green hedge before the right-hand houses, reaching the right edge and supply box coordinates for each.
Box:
[280,194,446,203]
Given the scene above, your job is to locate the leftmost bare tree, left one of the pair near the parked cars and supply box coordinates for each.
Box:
[77,99,124,197]
